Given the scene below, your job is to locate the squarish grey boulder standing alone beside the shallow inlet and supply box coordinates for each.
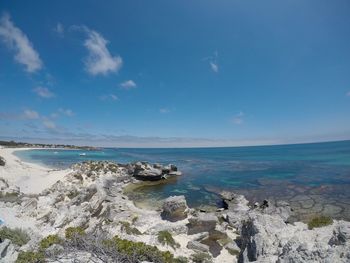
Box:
[161,195,188,222]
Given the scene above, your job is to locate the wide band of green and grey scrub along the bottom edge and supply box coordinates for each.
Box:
[16,233,187,263]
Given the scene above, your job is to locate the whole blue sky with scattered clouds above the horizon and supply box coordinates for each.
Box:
[0,0,350,147]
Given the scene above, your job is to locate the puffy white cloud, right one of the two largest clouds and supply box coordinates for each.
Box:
[83,27,123,75]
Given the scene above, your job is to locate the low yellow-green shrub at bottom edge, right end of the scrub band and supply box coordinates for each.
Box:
[105,236,176,263]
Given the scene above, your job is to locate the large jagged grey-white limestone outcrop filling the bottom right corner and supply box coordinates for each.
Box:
[222,192,350,263]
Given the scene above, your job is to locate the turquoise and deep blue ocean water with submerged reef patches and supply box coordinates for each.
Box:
[16,141,350,220]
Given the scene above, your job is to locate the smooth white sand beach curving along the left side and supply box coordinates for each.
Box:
[0,148,70,194]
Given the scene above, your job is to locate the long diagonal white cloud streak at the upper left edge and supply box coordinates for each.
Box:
[0,14,43,73]
